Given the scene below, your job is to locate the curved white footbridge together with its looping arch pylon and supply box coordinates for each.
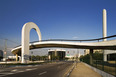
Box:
[11,22,116,63]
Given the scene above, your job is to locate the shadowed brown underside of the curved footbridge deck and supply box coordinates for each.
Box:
[12,43,116,55]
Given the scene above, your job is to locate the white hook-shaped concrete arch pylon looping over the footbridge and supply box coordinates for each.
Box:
[21,22,41,63]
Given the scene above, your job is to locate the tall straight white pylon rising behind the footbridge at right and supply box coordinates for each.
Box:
[103,9,107,61]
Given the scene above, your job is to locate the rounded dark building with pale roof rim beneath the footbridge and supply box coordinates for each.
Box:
[48,49,66,60]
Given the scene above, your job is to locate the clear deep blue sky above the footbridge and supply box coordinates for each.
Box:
[0,0,116,55]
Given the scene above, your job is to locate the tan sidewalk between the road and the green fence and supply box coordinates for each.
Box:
[69,63,102,77]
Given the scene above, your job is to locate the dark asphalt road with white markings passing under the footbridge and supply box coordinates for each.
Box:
[0,62,73,77]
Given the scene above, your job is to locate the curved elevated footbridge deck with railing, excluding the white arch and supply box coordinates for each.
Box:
[12,35,116,54]
